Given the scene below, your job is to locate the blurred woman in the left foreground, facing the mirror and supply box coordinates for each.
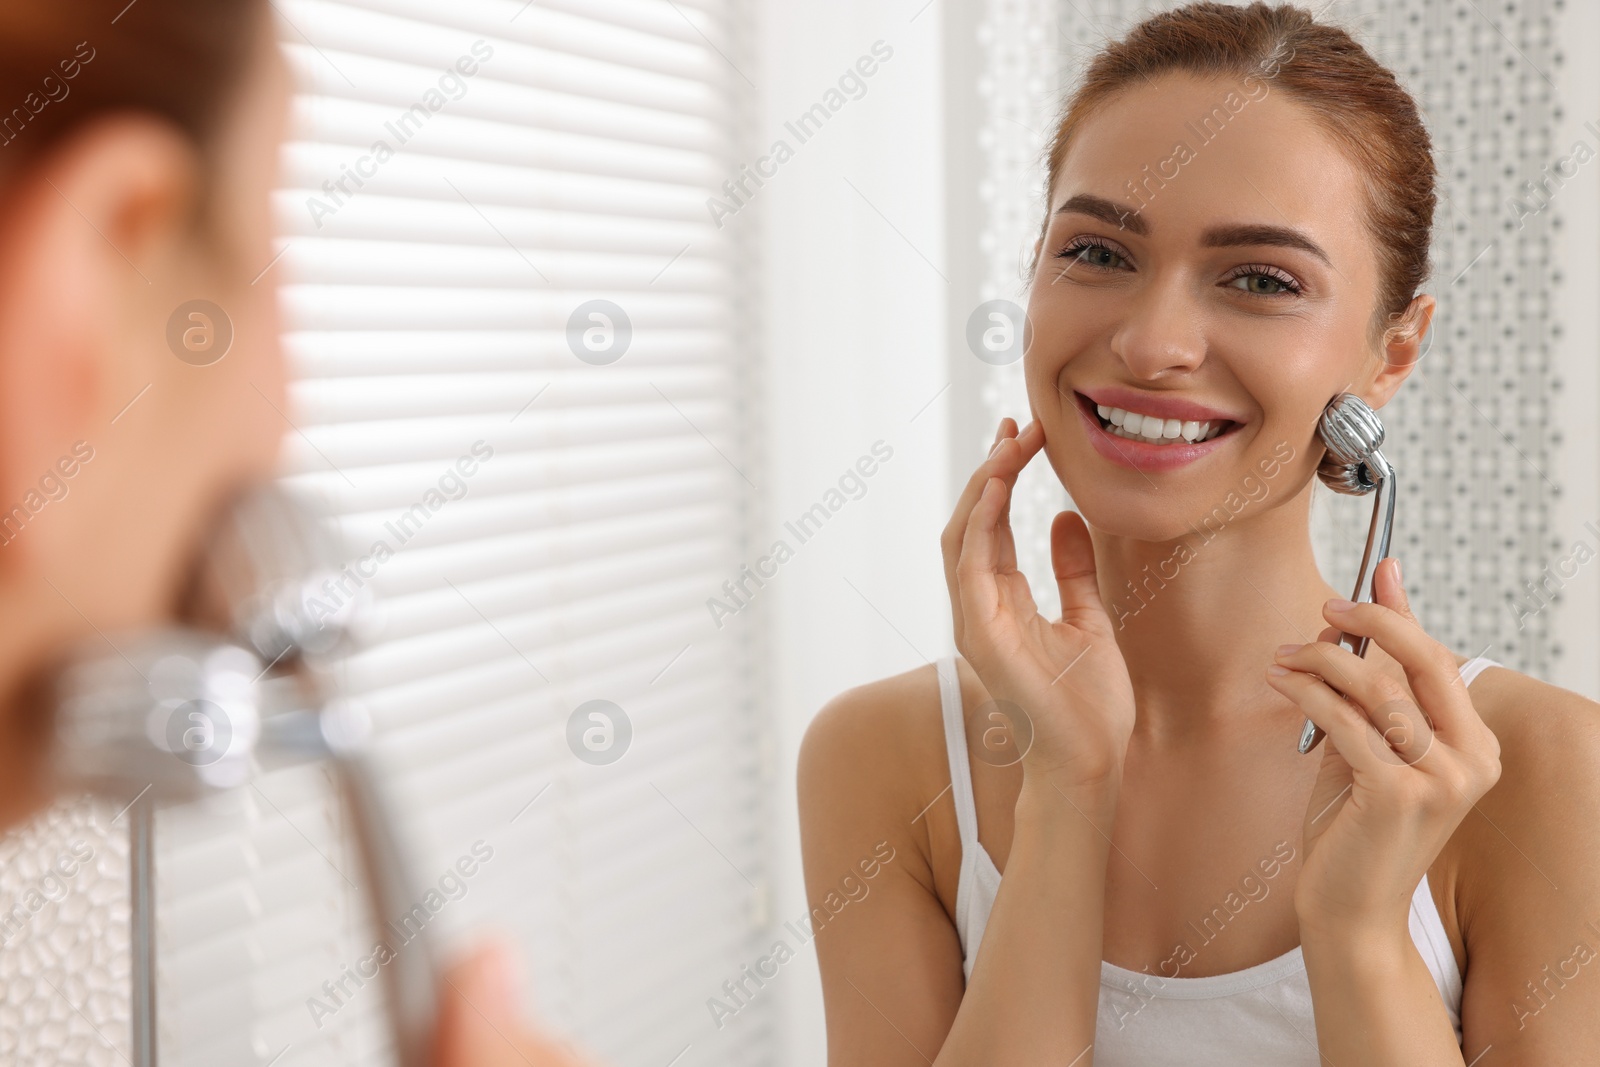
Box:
[0,0,595,1067]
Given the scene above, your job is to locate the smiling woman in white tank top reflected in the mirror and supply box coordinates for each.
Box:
[800,3,1600,1067]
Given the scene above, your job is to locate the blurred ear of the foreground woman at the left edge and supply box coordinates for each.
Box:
[0,114,198,572]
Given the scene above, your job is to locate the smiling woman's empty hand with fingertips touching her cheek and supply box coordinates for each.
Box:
[939,419,1134,787]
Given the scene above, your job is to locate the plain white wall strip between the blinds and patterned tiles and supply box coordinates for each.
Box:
[741,0,952,1067]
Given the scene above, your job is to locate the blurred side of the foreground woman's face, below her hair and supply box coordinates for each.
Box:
[21,16,291,629]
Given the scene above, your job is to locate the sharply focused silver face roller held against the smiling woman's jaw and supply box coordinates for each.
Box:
[1298,394,1395,752]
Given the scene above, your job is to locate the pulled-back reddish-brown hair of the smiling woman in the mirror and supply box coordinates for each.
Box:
[1046,0,1435,336]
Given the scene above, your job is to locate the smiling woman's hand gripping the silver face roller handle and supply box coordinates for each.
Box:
[1267,557,1501,931]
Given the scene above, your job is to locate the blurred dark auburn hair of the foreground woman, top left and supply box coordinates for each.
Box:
[0,0,267,203]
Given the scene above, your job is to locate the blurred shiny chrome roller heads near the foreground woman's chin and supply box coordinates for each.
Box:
[43,485,368,801]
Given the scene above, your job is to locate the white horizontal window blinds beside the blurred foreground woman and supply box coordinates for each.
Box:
[163,0,771,1067]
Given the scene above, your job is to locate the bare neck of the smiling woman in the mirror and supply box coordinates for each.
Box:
[1094,486,1346,742]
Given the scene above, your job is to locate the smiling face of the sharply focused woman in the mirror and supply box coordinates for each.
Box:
[1024,75,1426,541]
